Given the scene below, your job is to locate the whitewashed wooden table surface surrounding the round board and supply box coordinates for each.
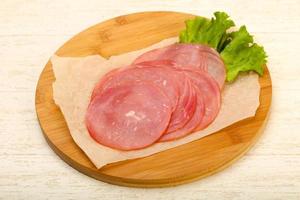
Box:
[0,0,300,200]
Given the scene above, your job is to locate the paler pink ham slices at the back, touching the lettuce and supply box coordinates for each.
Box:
[134,44,226,88]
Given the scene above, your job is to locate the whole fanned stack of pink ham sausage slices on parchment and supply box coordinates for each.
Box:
[86,44,226,150]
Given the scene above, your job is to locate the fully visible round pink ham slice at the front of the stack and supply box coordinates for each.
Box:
[86,82,172,150]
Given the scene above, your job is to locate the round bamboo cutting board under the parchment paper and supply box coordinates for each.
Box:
[35,12,272,187]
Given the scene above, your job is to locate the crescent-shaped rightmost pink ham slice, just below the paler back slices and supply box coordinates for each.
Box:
[184,69,221,130]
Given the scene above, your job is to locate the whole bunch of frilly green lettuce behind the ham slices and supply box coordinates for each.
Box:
[179,12,267,81]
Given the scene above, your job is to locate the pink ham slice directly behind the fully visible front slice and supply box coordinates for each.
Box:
[92,64,179,110]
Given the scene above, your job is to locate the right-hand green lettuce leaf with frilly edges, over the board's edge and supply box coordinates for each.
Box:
[221,26,267,81]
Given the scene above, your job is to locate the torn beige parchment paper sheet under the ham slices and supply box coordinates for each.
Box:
[51,38,260,168]
